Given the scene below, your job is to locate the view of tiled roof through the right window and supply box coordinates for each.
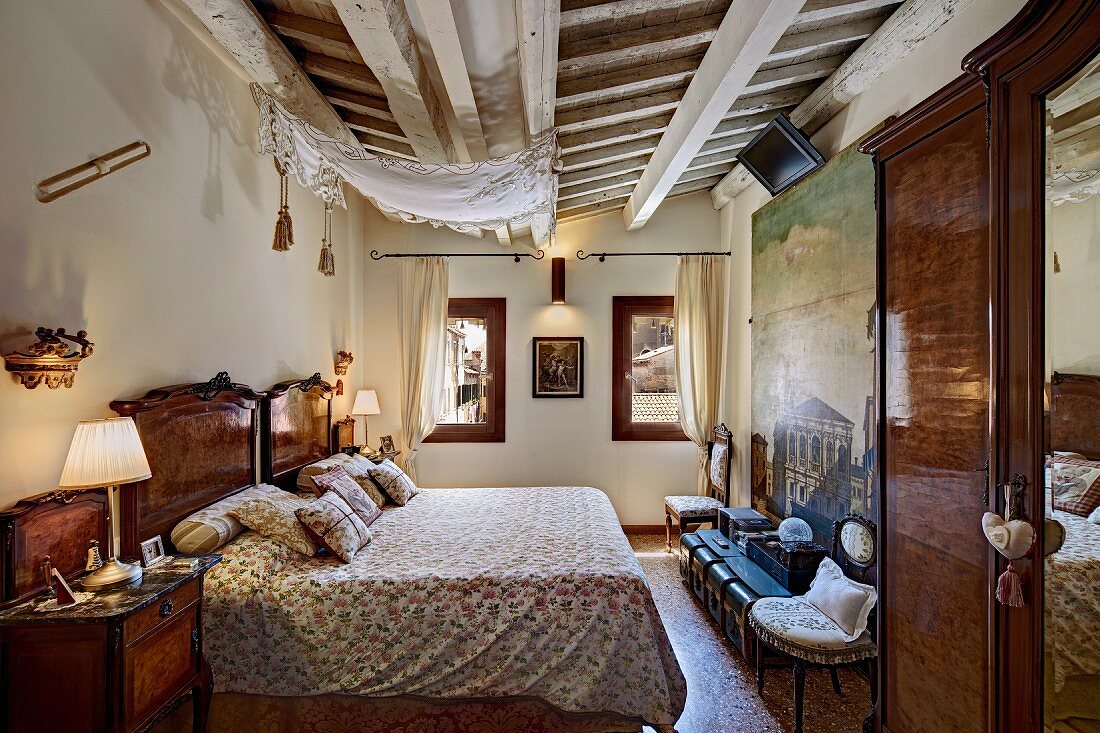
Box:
[630,315,680,423]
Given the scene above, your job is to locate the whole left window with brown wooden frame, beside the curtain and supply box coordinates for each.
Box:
[425,298,505,442]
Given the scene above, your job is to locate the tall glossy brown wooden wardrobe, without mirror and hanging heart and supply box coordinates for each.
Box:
[862,0,1100,733]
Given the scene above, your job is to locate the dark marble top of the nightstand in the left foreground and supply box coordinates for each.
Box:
[0,555,221,626]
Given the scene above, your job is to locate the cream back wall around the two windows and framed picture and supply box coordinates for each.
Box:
[359,193,721,524]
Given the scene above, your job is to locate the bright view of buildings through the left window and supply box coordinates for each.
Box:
[439,318,491,425]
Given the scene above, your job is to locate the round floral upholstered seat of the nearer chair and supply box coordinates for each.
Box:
[749,598,878,665]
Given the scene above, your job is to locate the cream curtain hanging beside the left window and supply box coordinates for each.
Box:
[397,258,447,482]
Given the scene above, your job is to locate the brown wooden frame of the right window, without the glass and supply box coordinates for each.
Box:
[612,295,688,440]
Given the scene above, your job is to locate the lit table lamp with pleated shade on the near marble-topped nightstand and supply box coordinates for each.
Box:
[58,417,153,591]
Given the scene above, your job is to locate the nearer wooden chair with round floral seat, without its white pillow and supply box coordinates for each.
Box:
[749,514,878,733]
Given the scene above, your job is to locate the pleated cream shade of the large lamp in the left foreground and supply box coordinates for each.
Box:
[58,417,153,489]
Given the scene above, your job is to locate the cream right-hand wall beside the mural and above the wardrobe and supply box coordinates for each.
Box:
[722,0,1025,504]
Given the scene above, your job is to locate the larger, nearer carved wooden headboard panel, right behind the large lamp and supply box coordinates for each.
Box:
[111,372,263,556]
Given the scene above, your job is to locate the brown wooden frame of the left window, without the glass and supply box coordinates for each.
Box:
[424,298,507,442]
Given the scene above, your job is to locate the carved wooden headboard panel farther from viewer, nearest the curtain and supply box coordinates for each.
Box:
[260,373,336,491]
